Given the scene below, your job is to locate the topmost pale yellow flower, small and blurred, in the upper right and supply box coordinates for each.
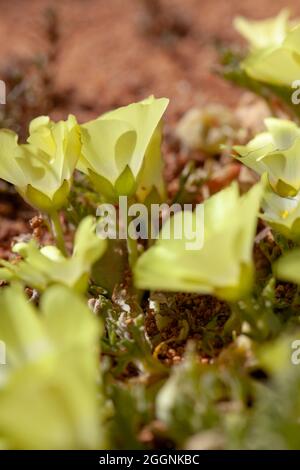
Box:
[233,9,291,49]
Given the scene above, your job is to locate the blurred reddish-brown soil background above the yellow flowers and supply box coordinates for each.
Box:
[0,0,300,130]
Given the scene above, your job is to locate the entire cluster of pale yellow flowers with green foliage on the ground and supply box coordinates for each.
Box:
[0,11,300,449]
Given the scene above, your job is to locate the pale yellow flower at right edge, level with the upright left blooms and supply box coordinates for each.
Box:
[233,118,300,197]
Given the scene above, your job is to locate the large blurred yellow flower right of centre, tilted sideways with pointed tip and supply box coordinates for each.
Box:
[134,183,262,300]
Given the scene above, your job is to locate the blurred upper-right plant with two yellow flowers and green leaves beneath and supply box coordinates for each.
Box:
[219,10,300,119]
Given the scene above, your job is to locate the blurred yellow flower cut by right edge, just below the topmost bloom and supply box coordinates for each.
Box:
[241,21,300,87]
